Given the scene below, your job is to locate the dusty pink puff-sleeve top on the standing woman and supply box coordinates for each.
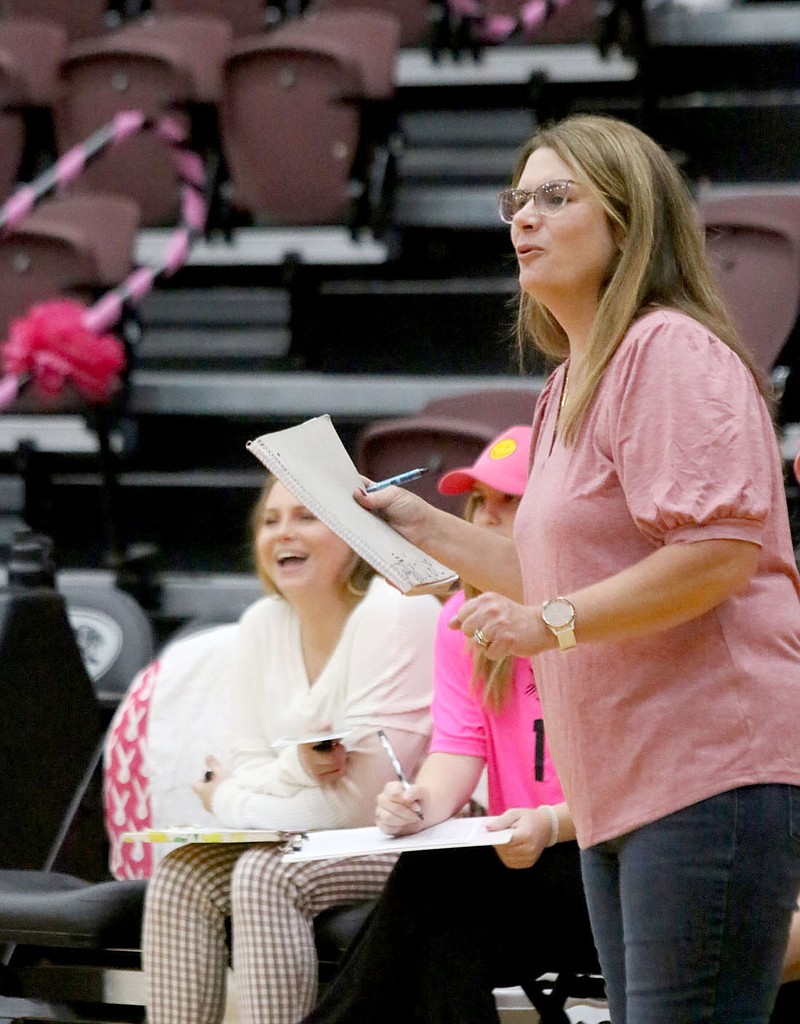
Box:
[514,310,800,847]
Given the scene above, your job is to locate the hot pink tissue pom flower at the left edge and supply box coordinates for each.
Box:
[0,299,125,402]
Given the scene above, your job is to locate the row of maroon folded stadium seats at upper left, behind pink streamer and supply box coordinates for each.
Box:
[0,10,399,234]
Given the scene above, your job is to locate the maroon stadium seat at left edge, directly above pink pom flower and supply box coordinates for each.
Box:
[0,195,138,348]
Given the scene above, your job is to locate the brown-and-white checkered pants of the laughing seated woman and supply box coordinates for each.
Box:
[142,844,396,1024]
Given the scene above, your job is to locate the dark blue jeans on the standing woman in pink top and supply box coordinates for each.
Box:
[581,784,800,1024]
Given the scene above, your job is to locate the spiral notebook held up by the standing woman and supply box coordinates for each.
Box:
[247,415,458,594]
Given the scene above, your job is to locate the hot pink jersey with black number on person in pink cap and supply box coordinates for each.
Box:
[430,593,563,814]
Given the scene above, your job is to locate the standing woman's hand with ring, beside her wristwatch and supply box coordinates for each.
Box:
[449,593,552,662]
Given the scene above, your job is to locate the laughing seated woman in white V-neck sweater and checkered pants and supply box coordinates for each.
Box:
[142,478,439,1024]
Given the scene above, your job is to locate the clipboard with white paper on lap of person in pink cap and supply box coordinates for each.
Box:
[284,817,514,861]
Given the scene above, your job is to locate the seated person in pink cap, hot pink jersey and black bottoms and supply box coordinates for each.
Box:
[303,426,598,1024]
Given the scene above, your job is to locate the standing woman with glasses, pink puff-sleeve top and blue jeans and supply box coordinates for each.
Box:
[361,116,800,1024]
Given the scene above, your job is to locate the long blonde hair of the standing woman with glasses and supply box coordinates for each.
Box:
[512,115,772,442]
